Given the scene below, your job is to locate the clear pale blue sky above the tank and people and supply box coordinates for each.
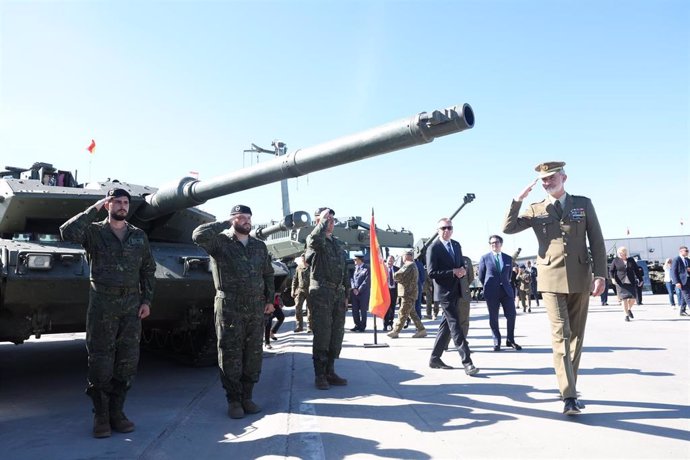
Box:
[0,0,690,260]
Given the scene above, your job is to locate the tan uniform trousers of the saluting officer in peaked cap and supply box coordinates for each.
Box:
[542,292,589,398]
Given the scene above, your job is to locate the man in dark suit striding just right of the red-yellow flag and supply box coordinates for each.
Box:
[426,218,479,375]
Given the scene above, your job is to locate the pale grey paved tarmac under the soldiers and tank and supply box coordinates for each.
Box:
[0,295,690,460]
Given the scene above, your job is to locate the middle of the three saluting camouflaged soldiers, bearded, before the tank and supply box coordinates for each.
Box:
[192,205,275,418]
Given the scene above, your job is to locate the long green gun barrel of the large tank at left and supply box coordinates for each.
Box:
[136,104,474,221]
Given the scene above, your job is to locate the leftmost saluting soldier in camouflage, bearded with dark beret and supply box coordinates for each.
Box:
[60,189,156,438]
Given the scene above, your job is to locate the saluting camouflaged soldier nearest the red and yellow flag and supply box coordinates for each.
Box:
[306,208,348,390]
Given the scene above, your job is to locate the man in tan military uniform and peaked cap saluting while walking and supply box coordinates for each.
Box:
[503,161,606,415]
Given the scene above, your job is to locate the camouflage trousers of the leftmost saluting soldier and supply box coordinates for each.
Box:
[86,289,141,398]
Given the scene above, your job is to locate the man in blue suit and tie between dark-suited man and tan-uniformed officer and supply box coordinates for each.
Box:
[479,235,522,351]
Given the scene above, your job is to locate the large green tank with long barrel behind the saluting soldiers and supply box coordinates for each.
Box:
[0,104,474,364]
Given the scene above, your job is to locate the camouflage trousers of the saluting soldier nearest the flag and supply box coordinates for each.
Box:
[309,286,347,376]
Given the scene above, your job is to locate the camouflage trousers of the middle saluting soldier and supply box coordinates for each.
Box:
[214,292,266,401]
